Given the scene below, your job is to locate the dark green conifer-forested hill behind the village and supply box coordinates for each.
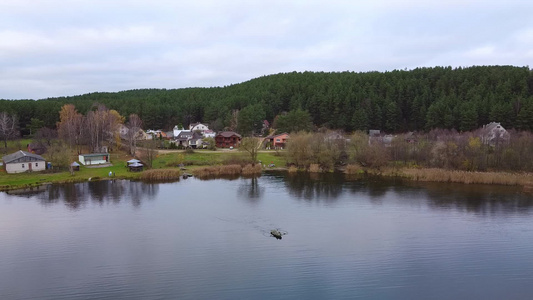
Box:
[0,66,533,132]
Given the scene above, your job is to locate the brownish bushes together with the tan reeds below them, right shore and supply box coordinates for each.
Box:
[286,130,533,186]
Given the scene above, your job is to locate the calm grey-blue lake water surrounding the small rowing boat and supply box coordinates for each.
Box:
[0,173,533,300]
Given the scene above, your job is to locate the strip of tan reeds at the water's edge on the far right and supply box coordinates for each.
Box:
[401,169,533,186]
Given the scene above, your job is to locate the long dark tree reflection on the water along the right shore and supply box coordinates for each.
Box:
[272,172,533,214]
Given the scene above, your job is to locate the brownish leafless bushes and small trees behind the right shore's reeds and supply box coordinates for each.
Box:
[286,129,533,172]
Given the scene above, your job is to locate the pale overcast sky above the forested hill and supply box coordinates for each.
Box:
[0,0,533,99]
